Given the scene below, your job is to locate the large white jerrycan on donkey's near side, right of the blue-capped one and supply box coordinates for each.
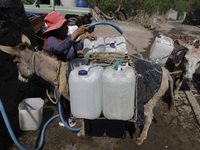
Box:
[102,66,136,120]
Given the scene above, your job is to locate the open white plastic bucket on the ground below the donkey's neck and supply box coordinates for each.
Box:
[18,98,44,131]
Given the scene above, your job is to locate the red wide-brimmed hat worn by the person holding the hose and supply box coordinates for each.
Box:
[44,11,70,33]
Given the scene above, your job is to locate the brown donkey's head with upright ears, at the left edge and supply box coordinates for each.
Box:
[0,35,34,82]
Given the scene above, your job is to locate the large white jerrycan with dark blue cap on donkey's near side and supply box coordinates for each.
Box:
[69,65,103,119]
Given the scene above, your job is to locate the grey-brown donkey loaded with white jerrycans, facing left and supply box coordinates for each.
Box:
[0,35,174,145]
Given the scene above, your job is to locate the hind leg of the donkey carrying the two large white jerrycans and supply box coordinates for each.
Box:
[136,98,157,145]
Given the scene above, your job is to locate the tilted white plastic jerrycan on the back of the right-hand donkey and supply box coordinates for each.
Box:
[149,35,174,66]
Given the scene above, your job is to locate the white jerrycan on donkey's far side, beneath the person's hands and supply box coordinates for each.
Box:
[83,37,105,58]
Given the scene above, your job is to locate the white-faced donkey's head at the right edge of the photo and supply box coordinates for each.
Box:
[179,40,200,80]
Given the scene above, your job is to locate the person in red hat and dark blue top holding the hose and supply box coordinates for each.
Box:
[44,11,97,127]
